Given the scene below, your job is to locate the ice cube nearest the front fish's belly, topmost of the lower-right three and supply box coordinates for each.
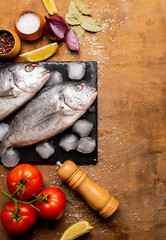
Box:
[72,119,93,137]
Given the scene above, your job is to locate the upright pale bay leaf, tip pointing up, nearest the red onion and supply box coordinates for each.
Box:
[65,1,81,25]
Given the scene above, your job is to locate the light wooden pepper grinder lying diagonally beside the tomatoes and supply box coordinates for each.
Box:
[58,160,119,219]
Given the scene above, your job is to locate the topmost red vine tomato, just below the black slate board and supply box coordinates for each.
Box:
[7,164,43,200]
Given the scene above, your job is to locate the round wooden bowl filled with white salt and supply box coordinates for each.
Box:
[15,10,44,40]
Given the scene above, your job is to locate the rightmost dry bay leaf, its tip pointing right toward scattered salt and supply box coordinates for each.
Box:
[81,15,102,32]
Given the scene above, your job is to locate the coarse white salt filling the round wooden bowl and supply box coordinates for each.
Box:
[17,13,40,34]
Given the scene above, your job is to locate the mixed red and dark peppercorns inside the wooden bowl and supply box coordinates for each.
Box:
[0,31,14,54]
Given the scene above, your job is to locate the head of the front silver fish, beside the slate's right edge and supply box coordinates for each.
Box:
[63,83,97,111]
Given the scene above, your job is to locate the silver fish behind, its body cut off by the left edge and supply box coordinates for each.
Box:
[0,63,50,120]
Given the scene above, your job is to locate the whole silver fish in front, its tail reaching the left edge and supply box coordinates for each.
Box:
[0,82,97,155]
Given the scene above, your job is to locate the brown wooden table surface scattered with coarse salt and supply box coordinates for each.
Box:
[0,0,166,240]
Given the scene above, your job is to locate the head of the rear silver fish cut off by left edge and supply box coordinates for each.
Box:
[10,63,50,93]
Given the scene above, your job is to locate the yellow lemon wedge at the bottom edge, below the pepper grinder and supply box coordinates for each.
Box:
[60,221,93,240]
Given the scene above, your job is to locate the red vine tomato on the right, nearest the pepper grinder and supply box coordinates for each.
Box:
[35,187,66,220]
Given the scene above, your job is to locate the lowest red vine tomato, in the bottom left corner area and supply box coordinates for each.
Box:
[1,201,37,235]
